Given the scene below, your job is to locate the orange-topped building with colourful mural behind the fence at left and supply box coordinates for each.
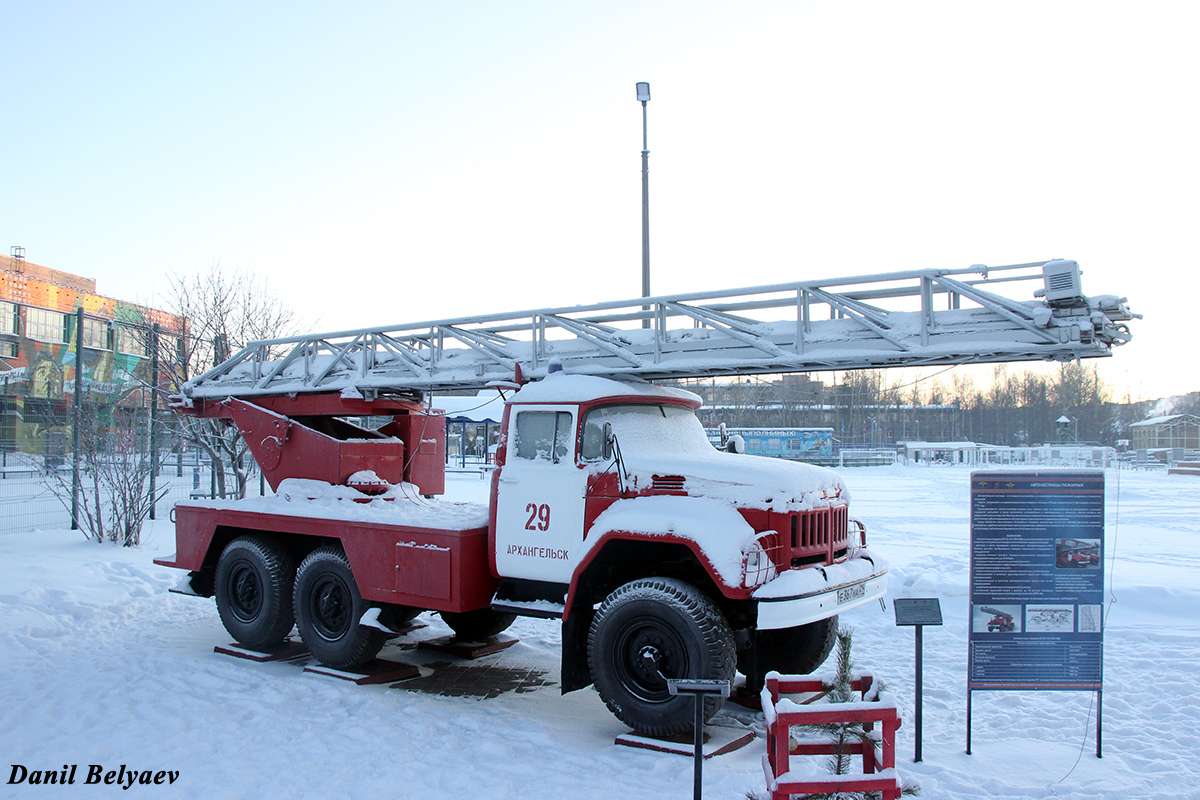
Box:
[0,247,186,462]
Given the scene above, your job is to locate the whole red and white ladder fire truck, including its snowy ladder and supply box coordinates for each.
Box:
[158,261,1130,735]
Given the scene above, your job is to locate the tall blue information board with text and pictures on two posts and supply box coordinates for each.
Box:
[967,470,1104,691]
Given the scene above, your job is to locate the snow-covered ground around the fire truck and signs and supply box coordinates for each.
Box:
[0,467,1200,800]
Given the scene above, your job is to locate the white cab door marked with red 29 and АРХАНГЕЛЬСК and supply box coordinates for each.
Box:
[496,405,588,583]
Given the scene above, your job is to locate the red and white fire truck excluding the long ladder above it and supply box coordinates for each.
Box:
[157,375,887,734]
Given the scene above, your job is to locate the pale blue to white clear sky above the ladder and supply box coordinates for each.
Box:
[0,0,1200,399]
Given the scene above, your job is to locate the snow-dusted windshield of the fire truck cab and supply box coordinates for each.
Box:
[580,403,713,461]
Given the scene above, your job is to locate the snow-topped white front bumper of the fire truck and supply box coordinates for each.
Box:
[752,549,888,631]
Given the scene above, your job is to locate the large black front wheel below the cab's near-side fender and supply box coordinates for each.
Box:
[588,578,736,736]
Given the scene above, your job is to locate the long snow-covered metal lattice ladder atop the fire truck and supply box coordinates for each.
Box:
[175,260,1139,399]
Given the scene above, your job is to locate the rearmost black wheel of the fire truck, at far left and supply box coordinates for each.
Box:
[214,535,296,648]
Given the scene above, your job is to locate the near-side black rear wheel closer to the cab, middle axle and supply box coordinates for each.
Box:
[295,547,388,668]
